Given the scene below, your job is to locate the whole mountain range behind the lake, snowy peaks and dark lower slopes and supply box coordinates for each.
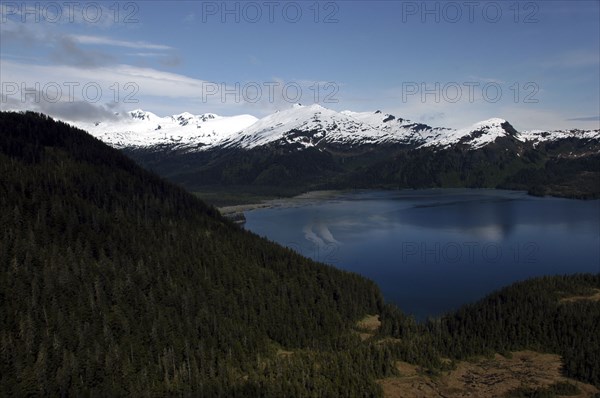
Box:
[67,104,600,205]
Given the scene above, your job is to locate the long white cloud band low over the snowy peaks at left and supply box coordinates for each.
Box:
[0,58,342,116]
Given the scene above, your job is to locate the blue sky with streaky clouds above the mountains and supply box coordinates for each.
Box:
[0,0,600,130]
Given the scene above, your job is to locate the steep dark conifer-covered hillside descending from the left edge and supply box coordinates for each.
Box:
[0,113,390,397]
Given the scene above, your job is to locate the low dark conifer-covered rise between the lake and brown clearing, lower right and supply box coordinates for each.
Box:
[380,274,600,386]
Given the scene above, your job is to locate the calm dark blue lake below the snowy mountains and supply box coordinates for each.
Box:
[245,189,600,319]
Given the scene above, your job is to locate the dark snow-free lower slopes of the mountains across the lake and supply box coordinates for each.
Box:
[124,137,600,205]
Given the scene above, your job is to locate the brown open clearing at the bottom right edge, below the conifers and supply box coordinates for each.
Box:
[379,351,599,398]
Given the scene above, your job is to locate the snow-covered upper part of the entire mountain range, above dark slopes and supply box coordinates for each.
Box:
[72,104,600,151]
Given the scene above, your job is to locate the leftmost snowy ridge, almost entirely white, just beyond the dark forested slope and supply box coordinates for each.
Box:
[72,109,258,149]
